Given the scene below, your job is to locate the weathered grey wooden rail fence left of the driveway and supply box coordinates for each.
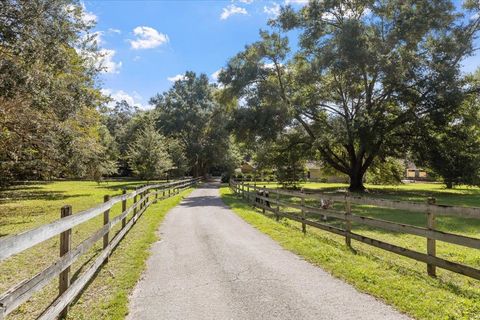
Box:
[0,178,200,320]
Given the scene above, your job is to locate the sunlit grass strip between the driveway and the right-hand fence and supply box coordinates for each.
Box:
[220,187,480,319]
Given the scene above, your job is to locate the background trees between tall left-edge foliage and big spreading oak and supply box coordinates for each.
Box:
[103,71,239,179]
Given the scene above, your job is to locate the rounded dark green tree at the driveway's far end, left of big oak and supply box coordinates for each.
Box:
[151,71,230,176]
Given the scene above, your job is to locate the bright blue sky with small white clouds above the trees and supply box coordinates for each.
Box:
[83,0,480,108]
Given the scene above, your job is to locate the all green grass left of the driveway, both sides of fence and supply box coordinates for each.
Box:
[0,181,195,319]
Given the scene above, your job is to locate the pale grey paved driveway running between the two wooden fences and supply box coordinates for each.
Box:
[127,184,408,320]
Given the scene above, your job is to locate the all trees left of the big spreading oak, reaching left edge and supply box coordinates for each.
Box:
[0,0,240,186]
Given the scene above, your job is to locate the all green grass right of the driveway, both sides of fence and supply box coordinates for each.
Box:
[221,182,480,319]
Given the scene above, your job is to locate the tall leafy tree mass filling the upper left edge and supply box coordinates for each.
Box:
[0,0,111,185]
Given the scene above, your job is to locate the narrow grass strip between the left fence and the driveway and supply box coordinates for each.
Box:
[69,188,193,320]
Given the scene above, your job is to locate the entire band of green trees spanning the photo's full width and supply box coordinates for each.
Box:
[0,0,480,191]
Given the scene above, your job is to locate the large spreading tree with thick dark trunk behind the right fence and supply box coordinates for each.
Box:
[219,0,480,191]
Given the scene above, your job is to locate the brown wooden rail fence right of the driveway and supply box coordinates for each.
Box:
[230,180,480,280]
